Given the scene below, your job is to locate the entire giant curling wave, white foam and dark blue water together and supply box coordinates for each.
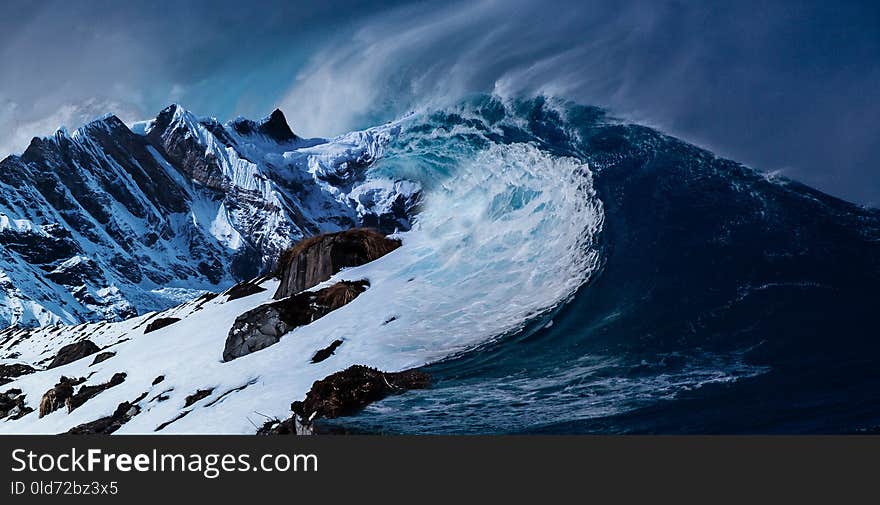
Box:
[318,97,877,433]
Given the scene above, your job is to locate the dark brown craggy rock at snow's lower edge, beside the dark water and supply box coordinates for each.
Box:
[290,365,431,424]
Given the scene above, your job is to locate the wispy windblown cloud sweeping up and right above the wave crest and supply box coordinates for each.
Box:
[280,0,880,201]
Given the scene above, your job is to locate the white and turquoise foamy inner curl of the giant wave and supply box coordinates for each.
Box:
[280,105,604,368]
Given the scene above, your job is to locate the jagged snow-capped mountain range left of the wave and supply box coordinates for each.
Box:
[0,105,419,326]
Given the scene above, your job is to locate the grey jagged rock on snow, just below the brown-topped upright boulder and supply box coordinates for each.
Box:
[223,280,370,361]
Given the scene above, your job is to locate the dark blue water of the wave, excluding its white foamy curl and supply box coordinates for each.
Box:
[318,97,880,433]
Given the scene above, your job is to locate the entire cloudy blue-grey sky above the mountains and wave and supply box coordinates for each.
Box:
[0,0,880,206]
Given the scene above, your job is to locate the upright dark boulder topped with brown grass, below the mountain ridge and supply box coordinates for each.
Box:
[274,228,400,300]
